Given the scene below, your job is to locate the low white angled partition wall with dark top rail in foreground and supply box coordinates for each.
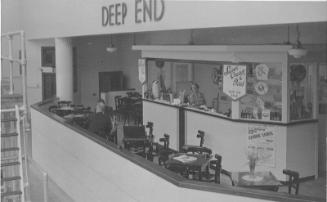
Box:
[31,100,319,202]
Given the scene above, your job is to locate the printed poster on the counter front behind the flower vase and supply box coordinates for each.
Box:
[247,125,276,167]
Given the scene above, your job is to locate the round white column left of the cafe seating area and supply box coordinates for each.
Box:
[55,38,74,101]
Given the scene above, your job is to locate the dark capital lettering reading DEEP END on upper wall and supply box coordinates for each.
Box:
[101,0,165,27]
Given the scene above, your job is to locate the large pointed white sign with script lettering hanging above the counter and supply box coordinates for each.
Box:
[223,65,246,100]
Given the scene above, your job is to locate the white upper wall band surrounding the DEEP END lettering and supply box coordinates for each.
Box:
[22,0,327,39]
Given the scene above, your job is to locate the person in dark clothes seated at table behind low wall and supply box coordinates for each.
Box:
[88,100,112,138]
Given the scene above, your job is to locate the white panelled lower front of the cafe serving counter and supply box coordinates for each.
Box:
[143,100,318,180]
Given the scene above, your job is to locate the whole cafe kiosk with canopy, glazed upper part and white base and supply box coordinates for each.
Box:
[139,45,318,180]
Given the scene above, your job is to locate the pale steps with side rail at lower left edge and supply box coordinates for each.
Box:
[1,105,28,202]
